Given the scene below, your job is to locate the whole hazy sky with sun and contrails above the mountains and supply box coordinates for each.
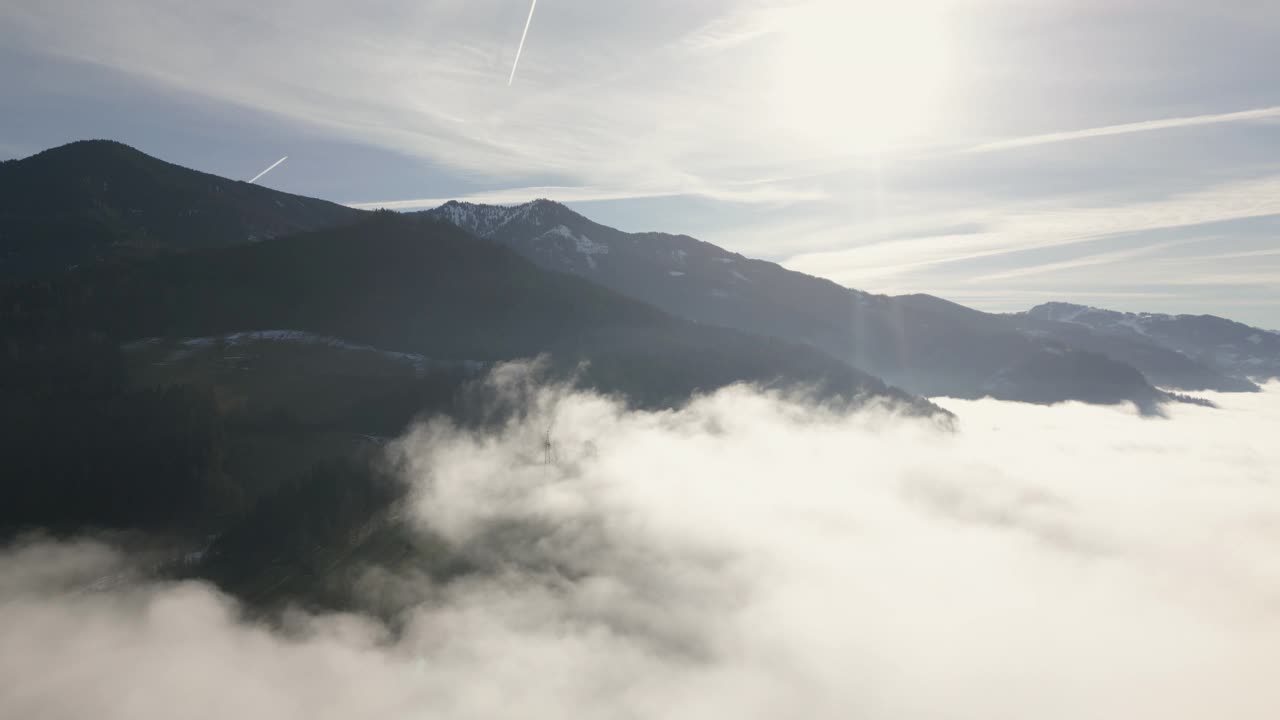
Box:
[0,0,1280,328]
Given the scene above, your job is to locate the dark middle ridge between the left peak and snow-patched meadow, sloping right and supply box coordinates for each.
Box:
[0,213,936,411]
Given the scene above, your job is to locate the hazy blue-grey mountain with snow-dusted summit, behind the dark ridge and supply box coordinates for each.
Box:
[426,200,1164,409]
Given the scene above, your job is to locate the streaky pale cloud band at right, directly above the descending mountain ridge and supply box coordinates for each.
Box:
[757,169,1280,320]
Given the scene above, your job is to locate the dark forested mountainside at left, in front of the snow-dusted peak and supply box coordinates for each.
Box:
[0,142,950,558]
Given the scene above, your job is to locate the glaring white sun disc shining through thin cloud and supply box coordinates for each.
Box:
[768,0,951,152]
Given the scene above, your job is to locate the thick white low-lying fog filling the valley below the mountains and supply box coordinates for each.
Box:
[0,368,1280,720]
